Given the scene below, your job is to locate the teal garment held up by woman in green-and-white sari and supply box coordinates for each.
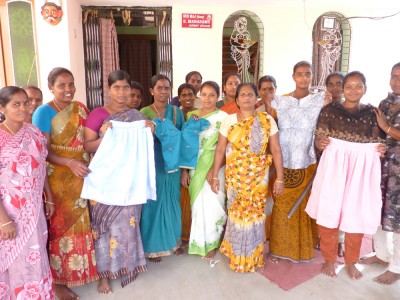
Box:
[179,118,211,169]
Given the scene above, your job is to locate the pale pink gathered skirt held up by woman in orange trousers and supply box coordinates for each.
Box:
[306,138,382,234]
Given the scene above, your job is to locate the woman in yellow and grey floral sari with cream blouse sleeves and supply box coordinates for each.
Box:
[208,83,283,272]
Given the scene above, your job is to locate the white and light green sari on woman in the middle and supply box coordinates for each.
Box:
[188,110,227,256]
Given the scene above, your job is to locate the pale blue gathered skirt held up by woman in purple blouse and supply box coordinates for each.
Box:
[81,121,156,206]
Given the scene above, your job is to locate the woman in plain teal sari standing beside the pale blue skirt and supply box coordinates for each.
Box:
[140,75,185,263]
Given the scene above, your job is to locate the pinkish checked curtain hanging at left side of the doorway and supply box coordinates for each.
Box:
[99,18,119,104]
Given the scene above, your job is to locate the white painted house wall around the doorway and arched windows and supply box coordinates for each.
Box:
[35,0,400,105]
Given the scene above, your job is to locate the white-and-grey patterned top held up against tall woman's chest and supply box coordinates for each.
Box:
[271,92,324,169]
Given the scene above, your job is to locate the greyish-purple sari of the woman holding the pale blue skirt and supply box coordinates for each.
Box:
[89,109,147,287]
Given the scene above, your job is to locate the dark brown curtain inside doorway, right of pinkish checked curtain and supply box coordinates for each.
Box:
[118,38,153,107]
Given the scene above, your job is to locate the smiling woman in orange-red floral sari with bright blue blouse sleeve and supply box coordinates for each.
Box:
[33,68,98,299]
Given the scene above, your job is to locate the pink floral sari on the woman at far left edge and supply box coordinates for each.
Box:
[0,124,54,299]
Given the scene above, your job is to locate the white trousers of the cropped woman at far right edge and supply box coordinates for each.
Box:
[373,226,400,274]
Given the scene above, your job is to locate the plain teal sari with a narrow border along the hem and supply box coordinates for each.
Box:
[140,104,184,258]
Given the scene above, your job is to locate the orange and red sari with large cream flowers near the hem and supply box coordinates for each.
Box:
[47,101,98,286]
